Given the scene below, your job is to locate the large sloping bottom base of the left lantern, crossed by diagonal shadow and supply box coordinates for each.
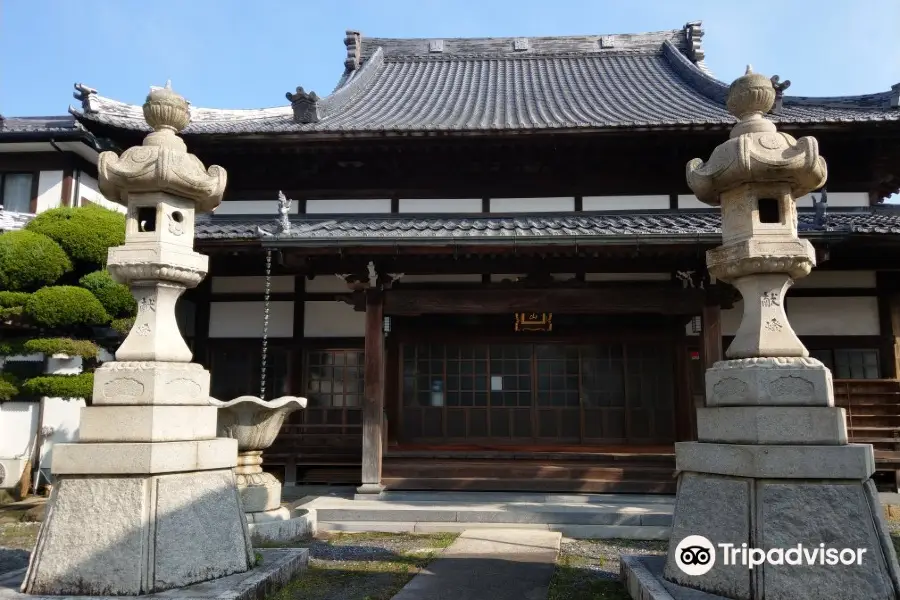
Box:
[22,468,254,596]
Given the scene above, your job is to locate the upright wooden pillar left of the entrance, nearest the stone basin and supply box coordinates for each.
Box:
[357,289,384,494]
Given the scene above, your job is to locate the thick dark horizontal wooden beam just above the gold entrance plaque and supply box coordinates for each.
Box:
[384,283,705,316]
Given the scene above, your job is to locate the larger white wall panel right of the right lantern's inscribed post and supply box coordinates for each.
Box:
[787,296,880,335]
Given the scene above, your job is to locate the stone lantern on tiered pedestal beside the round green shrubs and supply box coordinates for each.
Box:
[22,85,253,596]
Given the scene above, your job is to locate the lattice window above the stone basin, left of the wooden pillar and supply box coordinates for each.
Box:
[303,349,365,408]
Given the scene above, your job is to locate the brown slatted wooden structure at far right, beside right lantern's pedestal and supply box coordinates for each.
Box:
[834,379,900,492]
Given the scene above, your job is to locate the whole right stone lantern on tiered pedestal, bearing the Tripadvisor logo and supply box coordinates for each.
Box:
[641,67,900,600]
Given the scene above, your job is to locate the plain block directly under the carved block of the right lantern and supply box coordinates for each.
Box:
[697,406,847,445]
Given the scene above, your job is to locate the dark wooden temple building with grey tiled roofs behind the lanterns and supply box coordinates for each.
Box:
[0,22,900,493]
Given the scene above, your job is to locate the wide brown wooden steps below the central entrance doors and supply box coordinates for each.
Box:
[382,448,675,494]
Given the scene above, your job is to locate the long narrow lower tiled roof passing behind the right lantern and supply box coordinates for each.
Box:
[196,209,900,246]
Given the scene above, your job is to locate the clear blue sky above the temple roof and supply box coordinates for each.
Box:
[0,0,900,116]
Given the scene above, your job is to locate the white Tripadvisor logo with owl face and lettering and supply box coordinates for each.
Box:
[675,535,867,576]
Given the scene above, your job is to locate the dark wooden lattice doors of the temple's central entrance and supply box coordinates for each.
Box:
[398,339,676,445]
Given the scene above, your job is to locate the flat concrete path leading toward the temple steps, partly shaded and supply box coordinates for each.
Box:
[393,529,562,600]
